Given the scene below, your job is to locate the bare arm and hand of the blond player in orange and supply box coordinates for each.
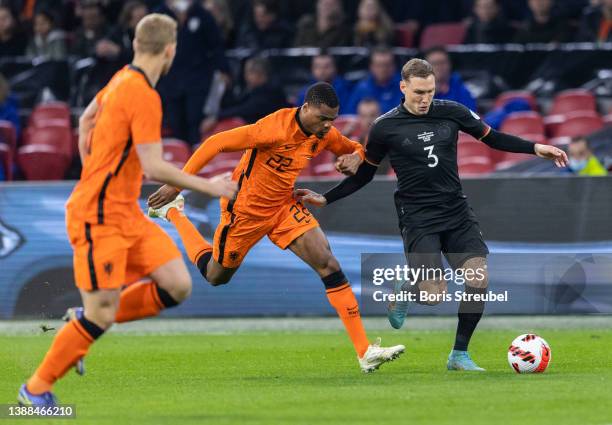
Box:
[136,143,238,198]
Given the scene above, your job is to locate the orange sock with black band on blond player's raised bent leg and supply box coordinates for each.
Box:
[115,280,178,323]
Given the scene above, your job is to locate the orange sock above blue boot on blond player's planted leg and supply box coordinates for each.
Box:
[27,317,104,394]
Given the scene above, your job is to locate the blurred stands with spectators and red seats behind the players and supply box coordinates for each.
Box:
[0,0,612,180]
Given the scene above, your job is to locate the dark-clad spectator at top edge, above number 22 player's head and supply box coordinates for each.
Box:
[295,0,352,48]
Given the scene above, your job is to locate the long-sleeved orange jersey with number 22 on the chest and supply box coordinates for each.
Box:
[183,108,364,217]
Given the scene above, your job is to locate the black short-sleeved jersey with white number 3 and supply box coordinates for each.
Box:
[366,100,489,231]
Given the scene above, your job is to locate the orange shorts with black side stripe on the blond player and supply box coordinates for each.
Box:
[67,217,181,291]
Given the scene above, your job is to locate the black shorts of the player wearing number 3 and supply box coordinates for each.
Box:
[401,220,489,269]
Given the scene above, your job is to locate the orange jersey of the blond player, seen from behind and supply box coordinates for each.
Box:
[66,65,162,230]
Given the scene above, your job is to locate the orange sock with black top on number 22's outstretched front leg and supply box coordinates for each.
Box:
[323,278,370,357]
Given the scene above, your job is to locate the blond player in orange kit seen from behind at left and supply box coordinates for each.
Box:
[18,14,237,406]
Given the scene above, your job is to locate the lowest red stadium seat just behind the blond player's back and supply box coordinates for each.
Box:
[17,145,71,180]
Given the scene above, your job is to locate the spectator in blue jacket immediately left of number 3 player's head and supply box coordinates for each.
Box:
[346,47,402,114]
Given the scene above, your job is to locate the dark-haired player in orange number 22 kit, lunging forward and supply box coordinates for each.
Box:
[149,83,404,372]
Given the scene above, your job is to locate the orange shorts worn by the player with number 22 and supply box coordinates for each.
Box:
[213,202,319,268]
